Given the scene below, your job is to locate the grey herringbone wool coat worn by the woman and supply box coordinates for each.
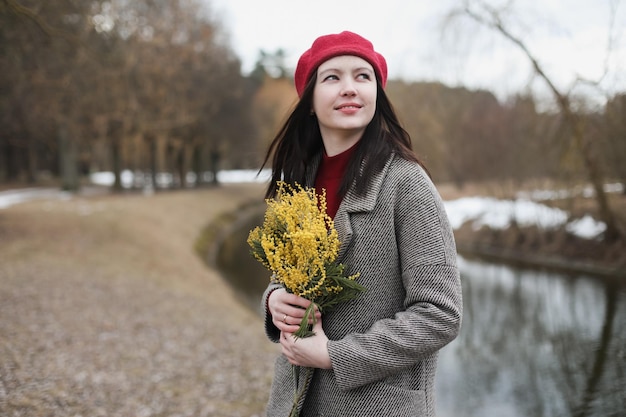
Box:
[263,157,462,417]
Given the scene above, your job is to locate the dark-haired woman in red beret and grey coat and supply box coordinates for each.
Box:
[263,32,461,417]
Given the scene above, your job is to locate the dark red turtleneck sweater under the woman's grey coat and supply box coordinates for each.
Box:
[315,142,358,218]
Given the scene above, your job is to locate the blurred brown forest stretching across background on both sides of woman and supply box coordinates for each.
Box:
[0,0,626,247]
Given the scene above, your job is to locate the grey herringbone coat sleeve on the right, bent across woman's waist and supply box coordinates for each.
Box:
[328,166,462,390]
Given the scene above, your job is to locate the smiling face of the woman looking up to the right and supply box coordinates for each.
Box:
[313,55,377,146]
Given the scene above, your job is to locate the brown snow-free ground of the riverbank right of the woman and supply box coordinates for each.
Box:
[438,185,626,282]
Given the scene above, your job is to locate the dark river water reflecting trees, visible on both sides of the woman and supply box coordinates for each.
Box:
[218,213,626,417]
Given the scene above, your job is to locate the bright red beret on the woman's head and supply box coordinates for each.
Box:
[294,31,387,97]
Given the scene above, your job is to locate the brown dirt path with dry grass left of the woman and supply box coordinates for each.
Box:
[0,185,278,417]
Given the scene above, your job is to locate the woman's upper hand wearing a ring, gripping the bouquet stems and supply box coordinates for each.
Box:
[267,288,321,333]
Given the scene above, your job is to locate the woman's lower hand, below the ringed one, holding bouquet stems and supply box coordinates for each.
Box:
[280,317,333,369]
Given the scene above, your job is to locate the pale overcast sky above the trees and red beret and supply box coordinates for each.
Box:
[203,0,626,101]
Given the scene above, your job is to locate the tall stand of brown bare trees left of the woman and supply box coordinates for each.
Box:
[0,0,251,189]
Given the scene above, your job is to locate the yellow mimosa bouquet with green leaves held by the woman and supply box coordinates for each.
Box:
[248,182,365,338]
